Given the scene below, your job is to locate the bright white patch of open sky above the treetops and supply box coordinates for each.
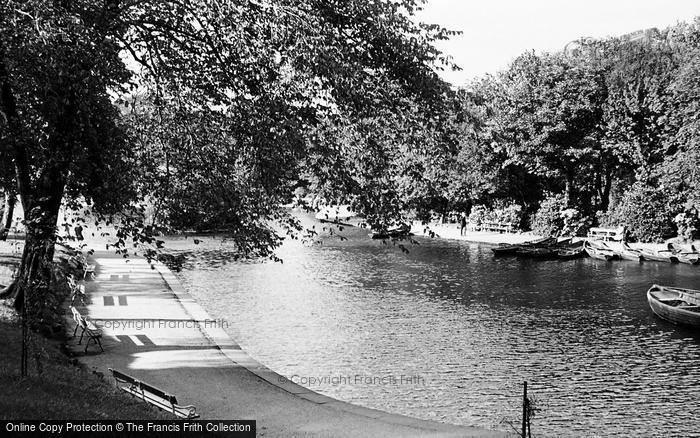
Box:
[418,0,700,86]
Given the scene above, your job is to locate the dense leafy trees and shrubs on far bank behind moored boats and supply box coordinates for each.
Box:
[435,21,700,241]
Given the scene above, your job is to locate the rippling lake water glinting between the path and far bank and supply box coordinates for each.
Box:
[170,236,700,437]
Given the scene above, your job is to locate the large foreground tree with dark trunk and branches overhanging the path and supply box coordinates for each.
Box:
[0,0,462,328]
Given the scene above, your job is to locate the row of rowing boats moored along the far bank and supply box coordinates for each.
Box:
[491,237,700,265]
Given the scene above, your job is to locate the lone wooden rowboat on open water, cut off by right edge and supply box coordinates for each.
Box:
[647,284,700,327]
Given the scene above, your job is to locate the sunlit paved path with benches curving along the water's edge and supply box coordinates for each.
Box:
[69,253,506,437]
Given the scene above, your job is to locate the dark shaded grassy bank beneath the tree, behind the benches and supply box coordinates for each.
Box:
[0,300,170,420]
